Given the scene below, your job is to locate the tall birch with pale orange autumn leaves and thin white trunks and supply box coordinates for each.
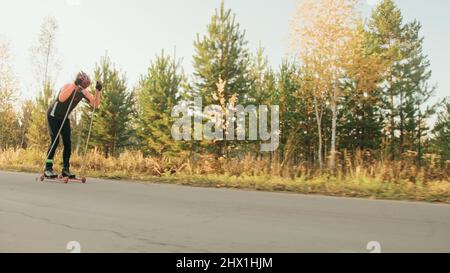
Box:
[290,0,359,169]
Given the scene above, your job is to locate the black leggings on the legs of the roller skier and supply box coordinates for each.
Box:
[47,115,72,168]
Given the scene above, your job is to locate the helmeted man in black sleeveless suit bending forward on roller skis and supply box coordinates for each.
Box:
[44,71,102,179]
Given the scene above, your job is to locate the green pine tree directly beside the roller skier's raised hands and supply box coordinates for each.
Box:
[81,56,134,157]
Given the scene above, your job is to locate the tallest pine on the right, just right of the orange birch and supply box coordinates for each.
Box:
[369,0,434,162]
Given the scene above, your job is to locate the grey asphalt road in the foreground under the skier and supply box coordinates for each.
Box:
[0,172,450,252]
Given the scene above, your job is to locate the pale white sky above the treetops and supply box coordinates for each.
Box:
[0,0,450,105]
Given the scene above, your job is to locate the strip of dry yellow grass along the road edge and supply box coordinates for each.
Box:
[0,149,450,204]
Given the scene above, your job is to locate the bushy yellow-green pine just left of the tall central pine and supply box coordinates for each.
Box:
[136,51,185,156]
